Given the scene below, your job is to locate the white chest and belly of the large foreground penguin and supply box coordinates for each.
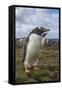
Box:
[25,34,41,65]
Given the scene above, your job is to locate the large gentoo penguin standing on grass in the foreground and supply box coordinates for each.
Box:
[23,27,49,74]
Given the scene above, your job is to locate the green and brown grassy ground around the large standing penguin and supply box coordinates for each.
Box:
[16,47,59,83]
